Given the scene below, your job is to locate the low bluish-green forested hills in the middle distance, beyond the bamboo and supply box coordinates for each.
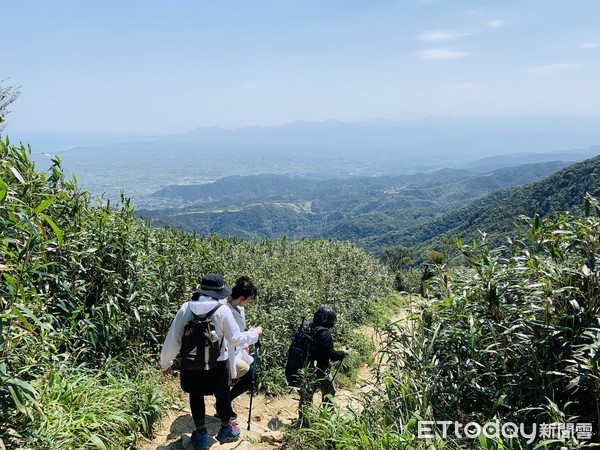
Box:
[138,162,566,252]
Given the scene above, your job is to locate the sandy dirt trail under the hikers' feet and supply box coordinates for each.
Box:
[136,314,402,450]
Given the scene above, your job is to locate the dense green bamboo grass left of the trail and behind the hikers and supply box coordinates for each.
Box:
[0,139,390,450]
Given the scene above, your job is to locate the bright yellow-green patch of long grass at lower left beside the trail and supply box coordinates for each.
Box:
[23,366,167,449]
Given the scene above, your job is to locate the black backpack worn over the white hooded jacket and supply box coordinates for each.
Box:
[181,303,223,370]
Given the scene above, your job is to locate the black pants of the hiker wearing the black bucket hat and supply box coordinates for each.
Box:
[181,361,231,426]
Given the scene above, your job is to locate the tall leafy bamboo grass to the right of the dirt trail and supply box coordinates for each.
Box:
[287,196,600,449]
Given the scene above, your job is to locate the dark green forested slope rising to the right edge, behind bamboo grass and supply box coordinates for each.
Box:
[370,156,600,248]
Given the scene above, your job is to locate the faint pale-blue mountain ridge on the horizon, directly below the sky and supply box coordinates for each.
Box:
[160,116,600,159]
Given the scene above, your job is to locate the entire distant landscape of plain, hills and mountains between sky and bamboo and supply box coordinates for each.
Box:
[23,117,600,258]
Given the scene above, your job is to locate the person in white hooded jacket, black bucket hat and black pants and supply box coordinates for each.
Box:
[160,273,262,449]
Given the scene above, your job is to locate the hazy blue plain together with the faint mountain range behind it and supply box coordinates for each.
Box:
[34,117,600,208]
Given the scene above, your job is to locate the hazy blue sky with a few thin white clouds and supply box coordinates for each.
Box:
[0,0,600,135]
